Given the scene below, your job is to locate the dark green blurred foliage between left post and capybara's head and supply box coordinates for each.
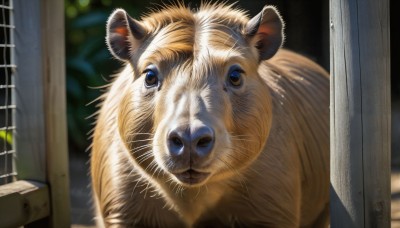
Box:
[65,0,119,151]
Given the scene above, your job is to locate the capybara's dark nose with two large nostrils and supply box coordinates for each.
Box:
[167,125,215,159]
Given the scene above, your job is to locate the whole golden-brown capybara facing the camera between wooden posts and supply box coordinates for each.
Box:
[91,3,329,227]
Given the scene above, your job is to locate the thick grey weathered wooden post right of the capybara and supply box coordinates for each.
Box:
[330,0,391,228]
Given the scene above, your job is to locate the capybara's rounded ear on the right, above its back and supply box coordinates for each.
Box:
[244,6,284,61]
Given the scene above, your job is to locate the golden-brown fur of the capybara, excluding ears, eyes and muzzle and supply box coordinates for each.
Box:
[91,2,329,227]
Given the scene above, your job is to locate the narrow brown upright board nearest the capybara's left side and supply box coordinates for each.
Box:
[41,0,71,228]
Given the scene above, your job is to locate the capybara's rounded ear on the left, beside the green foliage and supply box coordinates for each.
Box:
[106,9,147,61]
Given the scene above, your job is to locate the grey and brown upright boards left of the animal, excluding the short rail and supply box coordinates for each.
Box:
[14,0,70,227]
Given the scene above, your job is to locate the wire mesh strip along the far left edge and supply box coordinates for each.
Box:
[0,0,17,185]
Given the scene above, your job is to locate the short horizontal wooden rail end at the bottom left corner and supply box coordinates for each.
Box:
[0,181,50,227]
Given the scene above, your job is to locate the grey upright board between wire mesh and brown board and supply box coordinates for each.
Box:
[13,0,46,182]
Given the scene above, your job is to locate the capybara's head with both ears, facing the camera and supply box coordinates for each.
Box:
[107,5,283,187]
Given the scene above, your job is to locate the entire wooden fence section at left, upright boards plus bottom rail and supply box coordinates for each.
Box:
[0,0,70,227]
